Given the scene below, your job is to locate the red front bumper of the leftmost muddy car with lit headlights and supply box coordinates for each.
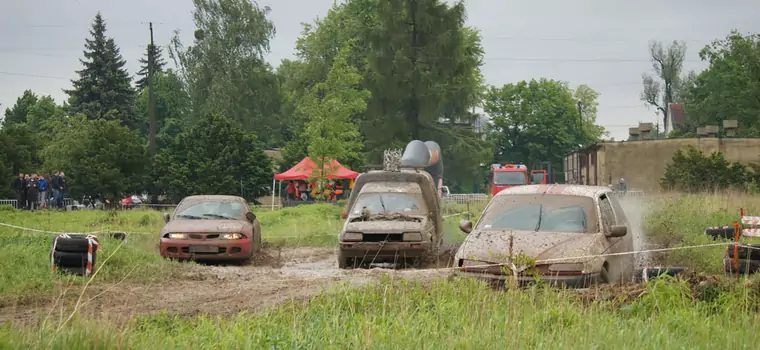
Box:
[160,238,251,260]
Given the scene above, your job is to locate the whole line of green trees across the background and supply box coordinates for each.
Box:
[0,0,760,201]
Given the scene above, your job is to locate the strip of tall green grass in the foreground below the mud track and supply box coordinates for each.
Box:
[0,279,760,349]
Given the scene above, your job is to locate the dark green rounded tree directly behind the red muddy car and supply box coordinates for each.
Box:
[156,115,273,202]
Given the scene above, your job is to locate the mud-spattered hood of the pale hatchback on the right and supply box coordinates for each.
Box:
[455,230,606,264]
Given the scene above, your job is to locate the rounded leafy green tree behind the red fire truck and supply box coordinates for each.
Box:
[484,79,603,176]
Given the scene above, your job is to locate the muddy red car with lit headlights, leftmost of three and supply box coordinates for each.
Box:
[160,195,261,261]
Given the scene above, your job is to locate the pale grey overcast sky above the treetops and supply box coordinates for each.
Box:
[0,0,760,139]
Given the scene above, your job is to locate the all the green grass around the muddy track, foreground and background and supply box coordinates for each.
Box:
[0,195,760,349]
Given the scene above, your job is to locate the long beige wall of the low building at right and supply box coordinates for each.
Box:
[596,138,760,191]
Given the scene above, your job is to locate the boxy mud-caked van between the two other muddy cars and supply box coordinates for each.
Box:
[338,170,443,268]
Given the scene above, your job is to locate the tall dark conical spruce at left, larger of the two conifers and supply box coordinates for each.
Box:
[64,12,138,128]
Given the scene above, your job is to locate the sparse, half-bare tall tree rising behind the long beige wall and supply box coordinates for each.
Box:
[641,40,686,135]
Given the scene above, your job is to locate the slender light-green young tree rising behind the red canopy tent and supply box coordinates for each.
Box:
[299,46,370,193]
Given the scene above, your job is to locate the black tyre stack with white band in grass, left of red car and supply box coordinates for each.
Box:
[50,234,100,276]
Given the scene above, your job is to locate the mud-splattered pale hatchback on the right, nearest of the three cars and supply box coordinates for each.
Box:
[454,185,634,287]
